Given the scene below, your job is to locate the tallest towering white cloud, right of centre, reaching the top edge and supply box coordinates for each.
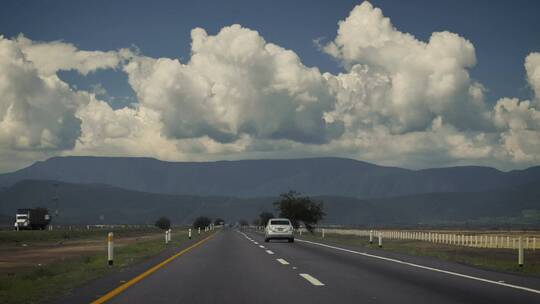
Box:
[324,2,486,133]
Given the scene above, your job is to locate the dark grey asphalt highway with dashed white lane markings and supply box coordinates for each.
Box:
[57,229,540,304]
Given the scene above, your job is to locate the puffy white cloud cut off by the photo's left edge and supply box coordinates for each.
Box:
[0,36,87,150]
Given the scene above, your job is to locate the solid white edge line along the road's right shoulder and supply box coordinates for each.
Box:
[297,239,540,294]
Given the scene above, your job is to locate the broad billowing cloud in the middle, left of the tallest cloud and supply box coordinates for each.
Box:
[125,25,343,143]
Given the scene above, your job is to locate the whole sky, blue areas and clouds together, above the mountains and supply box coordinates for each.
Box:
[0,0,540,172]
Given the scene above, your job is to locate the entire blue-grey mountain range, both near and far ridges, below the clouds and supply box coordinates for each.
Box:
[0,157,540,226]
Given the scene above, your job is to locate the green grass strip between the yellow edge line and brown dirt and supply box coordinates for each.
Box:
[0,231,210,304]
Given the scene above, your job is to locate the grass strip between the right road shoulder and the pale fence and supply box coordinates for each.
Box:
[298,234,540,276]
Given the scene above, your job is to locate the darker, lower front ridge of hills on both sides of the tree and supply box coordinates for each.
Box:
[0,181,540,226]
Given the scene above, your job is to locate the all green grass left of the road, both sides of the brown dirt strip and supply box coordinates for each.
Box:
[0,227,211,304]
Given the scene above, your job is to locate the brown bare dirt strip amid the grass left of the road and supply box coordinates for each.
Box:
[0,234,162,275]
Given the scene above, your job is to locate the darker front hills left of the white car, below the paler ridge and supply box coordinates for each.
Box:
[0,180,272,224]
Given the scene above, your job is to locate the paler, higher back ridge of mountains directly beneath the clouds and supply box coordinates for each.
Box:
[0,157,540,198]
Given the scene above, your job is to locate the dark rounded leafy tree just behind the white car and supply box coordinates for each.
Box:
[274,190,326,232]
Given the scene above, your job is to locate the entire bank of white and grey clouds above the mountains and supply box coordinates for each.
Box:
[0,2,540,170]
